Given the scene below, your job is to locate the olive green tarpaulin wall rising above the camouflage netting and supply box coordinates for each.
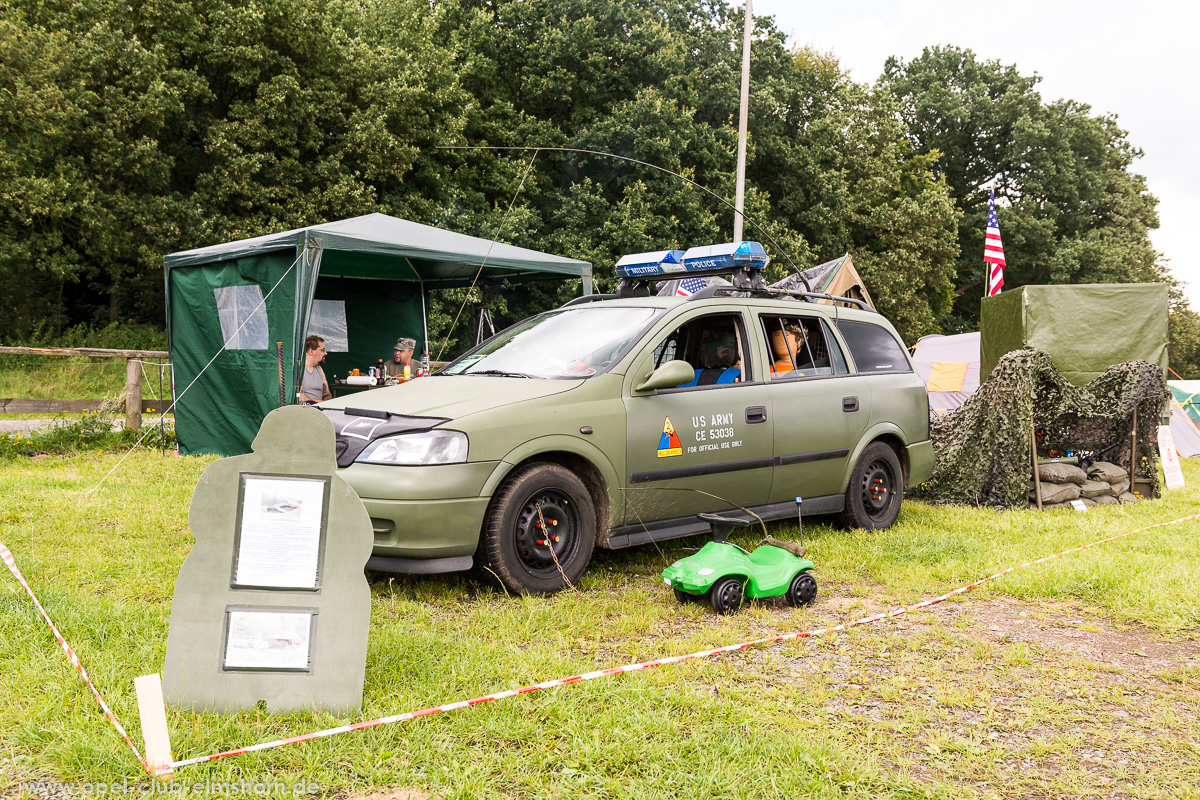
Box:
[979,283,1168,386]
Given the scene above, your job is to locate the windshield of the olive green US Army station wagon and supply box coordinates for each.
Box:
[442,306,658,378]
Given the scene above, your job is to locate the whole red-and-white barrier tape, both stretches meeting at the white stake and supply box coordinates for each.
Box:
[0,515,1200,774]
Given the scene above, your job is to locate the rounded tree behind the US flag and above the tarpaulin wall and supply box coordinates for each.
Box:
[881,47,1162,330]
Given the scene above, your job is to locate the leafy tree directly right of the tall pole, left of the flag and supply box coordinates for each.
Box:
[746,49,959,342]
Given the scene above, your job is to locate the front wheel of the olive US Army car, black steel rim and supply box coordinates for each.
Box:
[476,463,596,595]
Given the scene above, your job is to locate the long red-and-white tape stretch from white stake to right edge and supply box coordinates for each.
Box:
[170,515,1200,769]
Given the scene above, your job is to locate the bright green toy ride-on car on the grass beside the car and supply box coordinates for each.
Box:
[662,513,817,614]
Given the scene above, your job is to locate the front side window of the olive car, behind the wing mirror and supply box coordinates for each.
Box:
[654,314,750,389]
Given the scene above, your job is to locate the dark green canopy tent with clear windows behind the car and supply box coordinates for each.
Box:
[163,213,592,456]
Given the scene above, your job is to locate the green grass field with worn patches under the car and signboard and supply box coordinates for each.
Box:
[0,452,1200,799]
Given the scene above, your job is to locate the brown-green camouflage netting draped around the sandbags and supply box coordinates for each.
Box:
[914,350,1170,507]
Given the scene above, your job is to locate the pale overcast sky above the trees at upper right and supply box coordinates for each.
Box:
[751,0,1200,312]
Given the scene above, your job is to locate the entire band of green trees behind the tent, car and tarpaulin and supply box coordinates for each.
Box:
[0,0,1180,371]
